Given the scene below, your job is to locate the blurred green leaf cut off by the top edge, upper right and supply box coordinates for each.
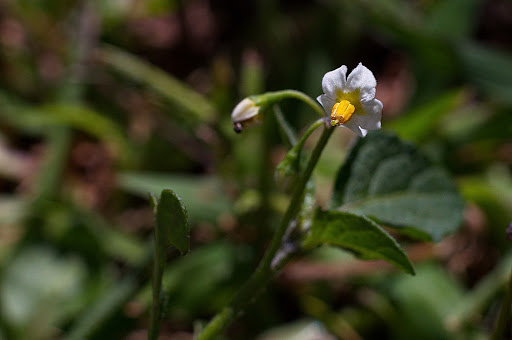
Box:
[425,0,482,39]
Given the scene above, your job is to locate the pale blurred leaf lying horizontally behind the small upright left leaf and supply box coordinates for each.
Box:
[118,172,231,221]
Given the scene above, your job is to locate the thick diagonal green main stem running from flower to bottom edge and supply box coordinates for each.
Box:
[196,126,334,340]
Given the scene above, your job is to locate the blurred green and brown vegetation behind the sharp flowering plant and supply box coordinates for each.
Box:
[0,0,512,340]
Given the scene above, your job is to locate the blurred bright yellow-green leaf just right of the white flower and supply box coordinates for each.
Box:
[386,90,464,141]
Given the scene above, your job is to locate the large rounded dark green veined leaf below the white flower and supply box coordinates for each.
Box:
[331,132,464,241]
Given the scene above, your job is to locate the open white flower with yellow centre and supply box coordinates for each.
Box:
[317,63,382,137]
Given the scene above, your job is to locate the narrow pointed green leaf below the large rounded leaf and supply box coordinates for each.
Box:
[304,209,414,274]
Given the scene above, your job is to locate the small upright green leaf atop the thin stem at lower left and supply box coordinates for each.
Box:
[156,189,190,254]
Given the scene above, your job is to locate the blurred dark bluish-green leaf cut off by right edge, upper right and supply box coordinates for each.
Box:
[456,43,512,106]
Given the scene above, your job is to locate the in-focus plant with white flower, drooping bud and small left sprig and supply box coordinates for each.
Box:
[150,64,463,340]
